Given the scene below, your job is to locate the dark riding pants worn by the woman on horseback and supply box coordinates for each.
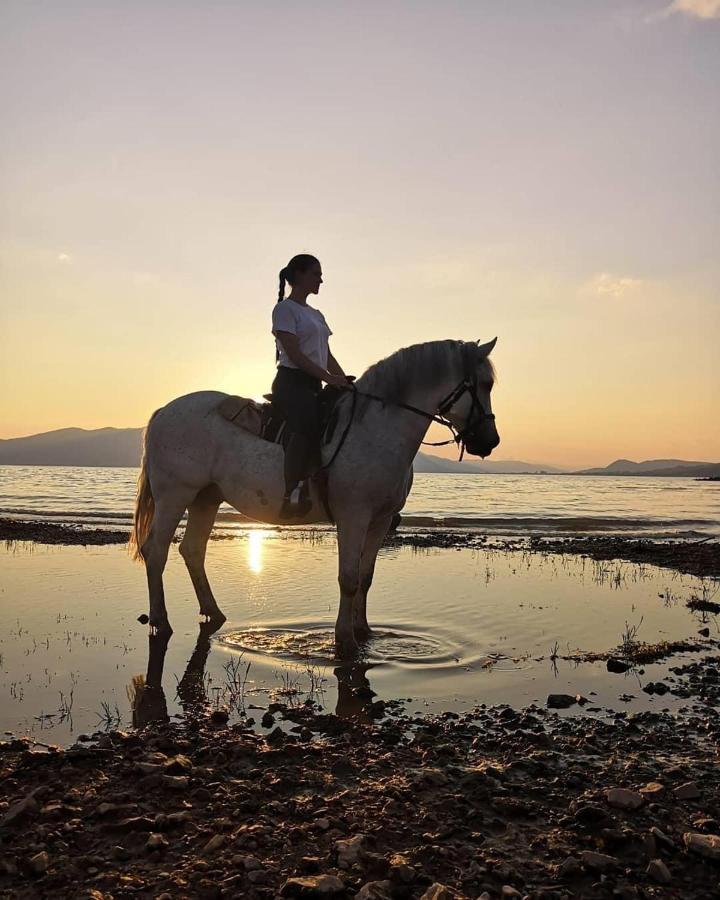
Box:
[272,366,322,494]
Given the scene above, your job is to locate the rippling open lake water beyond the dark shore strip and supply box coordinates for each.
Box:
[0,466,720,537]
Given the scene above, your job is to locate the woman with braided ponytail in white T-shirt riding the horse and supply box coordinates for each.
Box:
[272,253,352,520]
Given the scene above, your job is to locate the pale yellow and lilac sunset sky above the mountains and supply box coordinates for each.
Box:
[0,0,720,466]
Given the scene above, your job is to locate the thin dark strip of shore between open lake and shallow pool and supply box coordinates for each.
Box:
[0,518,720,578]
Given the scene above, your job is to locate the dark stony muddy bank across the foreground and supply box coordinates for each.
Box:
[0,658,720,900]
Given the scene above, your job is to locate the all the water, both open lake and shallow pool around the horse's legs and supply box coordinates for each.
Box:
[0,467,720,743]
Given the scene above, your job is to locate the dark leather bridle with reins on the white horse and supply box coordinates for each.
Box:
[322,344,495,469]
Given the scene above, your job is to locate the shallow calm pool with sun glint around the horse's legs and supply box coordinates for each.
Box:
[0,529,720,744]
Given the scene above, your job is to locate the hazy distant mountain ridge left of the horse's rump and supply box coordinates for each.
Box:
[0,428,143,466]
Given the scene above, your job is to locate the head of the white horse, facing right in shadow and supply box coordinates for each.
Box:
[445,338,500,459]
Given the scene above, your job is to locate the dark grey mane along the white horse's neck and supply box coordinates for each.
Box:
[357,340,495,403]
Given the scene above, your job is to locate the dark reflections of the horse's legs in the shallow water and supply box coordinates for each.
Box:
[128,622,382,728]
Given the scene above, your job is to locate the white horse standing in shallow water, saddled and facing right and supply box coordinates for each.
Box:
[130,340,500,658]
